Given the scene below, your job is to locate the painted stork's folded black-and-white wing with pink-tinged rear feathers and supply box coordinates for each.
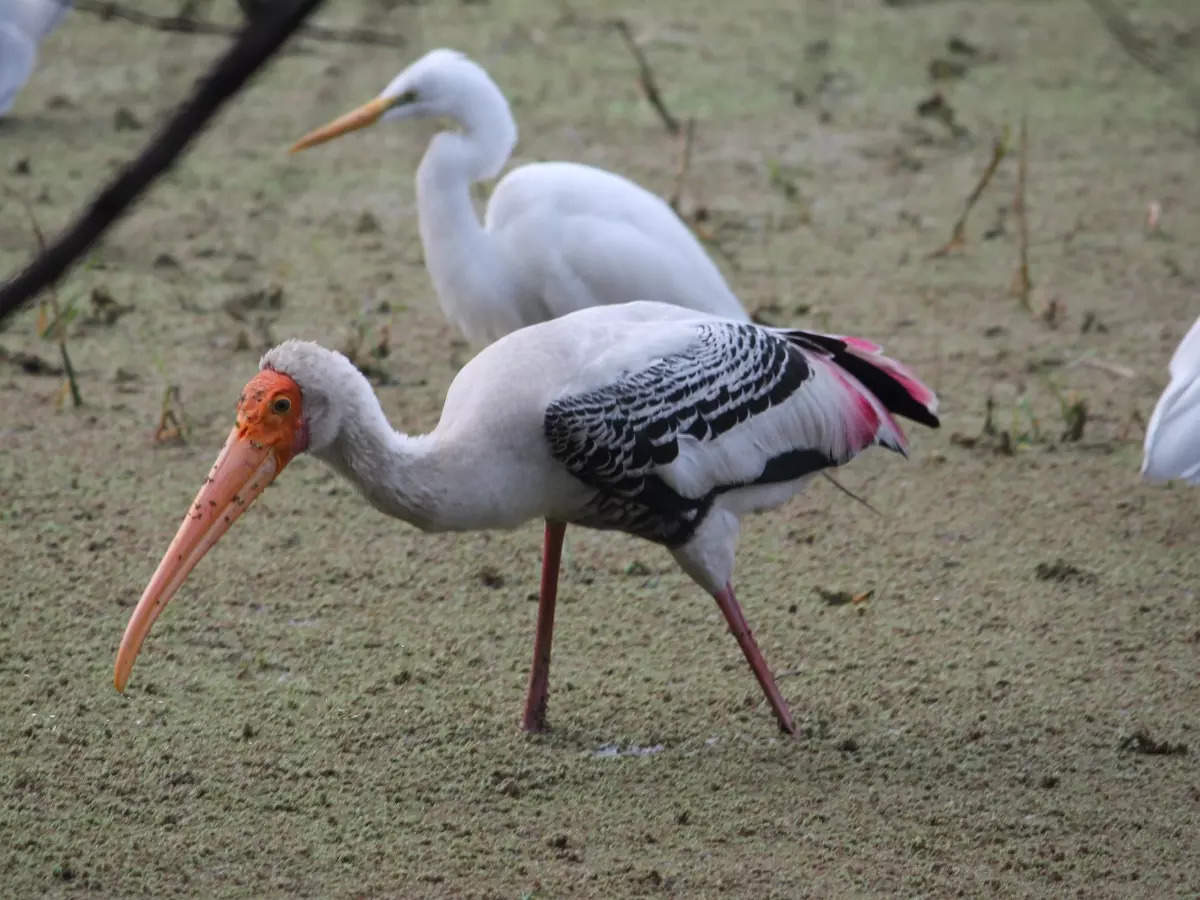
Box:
[544,322,937,546]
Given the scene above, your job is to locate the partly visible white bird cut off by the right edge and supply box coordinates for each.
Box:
[1141,319,1200,484]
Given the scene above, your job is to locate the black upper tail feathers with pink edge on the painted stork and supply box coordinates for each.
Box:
[782,329,941,428]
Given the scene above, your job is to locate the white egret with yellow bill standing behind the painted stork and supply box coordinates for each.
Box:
[292,49,748,346]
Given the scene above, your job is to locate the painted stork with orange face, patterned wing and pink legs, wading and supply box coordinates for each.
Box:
[114,302,938,733]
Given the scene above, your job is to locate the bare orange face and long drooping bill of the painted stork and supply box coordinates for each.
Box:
[113,368,308,691]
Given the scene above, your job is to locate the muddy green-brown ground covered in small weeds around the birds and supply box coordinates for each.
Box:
[0,0,1200,899]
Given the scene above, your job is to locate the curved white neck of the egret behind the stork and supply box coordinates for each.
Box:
[416,103,516,343]
